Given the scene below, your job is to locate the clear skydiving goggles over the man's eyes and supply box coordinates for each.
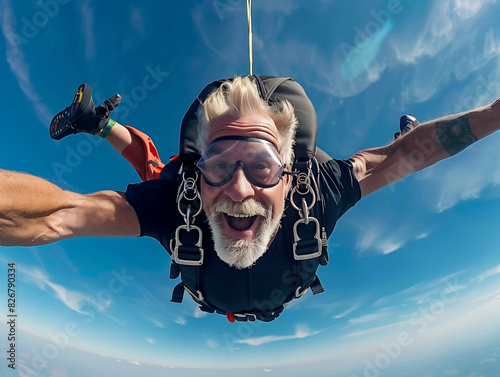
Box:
[196,136,285,188]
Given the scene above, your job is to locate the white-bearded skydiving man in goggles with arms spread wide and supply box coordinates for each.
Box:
[0,77,500,321]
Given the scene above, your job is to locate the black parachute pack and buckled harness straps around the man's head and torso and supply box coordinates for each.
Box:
[162,76,328,322]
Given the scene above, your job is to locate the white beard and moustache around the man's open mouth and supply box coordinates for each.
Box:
[208,199,280,269]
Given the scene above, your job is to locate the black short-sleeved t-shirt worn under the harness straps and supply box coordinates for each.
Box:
[126,160,361,313]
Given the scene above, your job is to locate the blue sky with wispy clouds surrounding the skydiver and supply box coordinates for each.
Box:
[0,0,500,377]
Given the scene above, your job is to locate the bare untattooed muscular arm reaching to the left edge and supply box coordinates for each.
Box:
[0,170,140,246]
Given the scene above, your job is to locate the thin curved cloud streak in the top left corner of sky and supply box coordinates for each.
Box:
[0,0,52,127]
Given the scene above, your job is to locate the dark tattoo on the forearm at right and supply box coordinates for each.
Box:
[436,115,477,156]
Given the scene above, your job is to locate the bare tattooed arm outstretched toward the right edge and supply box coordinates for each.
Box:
[350,100,500,196]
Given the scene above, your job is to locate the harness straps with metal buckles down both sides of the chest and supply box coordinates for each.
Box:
[170,160,328,322]
